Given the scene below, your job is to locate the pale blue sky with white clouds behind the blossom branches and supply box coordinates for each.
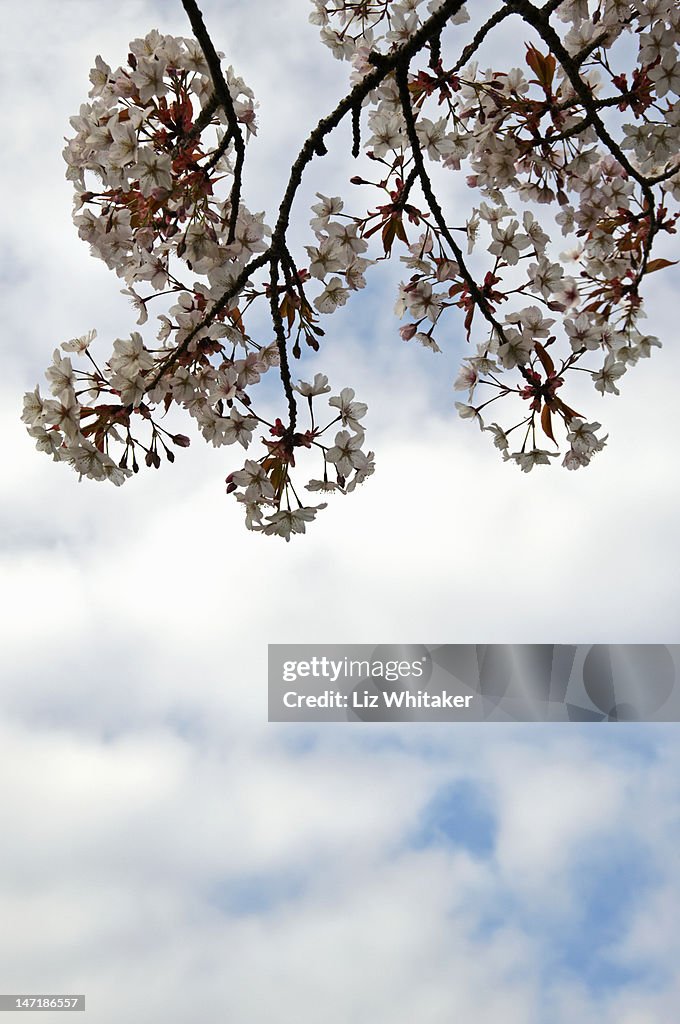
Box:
[0,0,680,1024]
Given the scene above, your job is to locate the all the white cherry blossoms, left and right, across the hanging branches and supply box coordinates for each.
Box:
[23,0,680,540]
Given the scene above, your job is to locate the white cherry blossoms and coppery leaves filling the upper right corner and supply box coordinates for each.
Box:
[311,0,680,471]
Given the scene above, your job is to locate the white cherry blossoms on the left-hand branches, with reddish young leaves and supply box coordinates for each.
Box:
[23,31,373,540]
